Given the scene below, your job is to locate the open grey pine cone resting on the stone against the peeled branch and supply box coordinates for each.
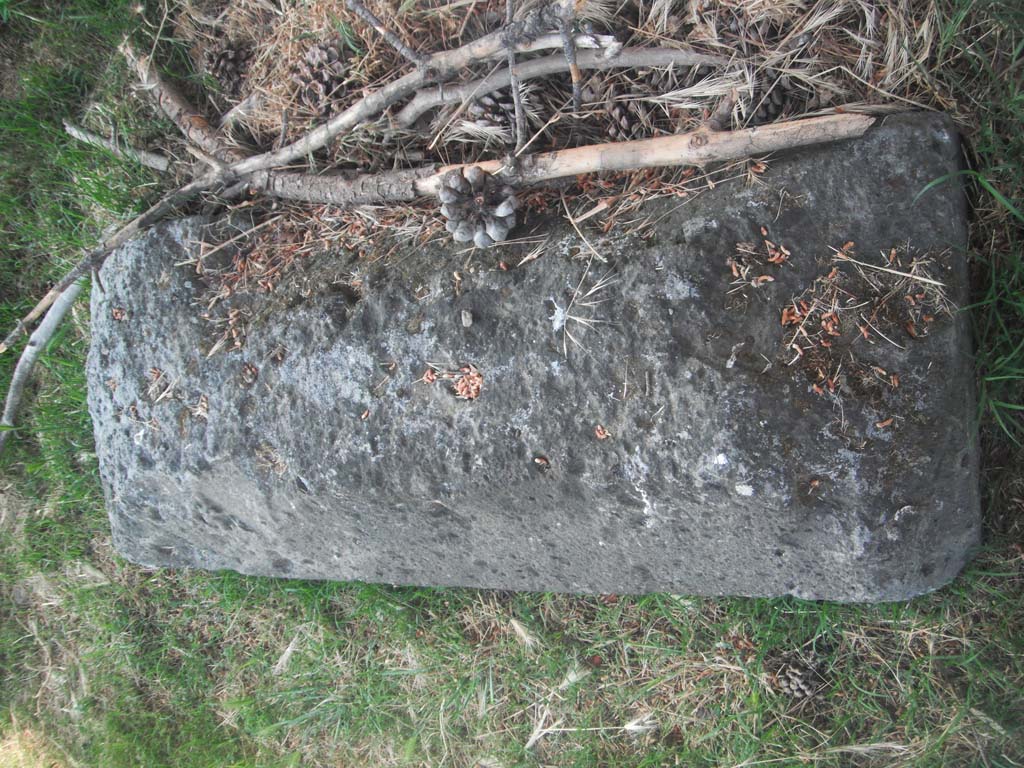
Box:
[437,166,516,248]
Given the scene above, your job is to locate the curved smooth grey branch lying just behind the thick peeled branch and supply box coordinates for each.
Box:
[396,48,729,128]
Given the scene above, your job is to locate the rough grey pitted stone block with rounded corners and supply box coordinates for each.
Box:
[88,116,979,601]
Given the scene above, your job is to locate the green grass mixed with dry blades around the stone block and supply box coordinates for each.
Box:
[0,0,1024,768]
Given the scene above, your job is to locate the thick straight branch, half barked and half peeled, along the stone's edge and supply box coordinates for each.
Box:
[255,114,874,206]
